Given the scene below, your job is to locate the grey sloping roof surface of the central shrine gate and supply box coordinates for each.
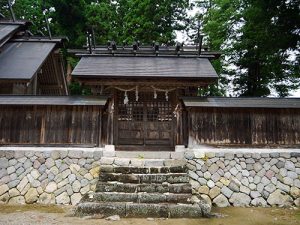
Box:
[72,55,218,79]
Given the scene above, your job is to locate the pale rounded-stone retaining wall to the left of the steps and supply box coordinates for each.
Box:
[0,148,103,205]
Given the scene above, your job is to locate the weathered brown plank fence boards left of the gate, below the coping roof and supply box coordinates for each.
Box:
[0,105,102,146]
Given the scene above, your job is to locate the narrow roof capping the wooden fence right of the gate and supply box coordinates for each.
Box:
[182,97,300,109]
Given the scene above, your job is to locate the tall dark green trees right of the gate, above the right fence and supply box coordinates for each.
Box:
[204,0,300,97]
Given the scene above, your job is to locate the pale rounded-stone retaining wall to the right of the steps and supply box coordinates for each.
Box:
[185,149,300,207]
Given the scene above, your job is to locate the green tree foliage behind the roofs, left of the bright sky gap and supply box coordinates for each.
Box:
[0,0,189,47]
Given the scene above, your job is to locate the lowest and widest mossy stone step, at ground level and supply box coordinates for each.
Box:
[75,202,202,218]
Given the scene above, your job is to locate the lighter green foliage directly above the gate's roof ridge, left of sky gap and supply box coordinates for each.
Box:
[86,0,188,44]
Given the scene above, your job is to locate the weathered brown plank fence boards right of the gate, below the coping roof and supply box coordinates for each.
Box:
[188,108,300,145]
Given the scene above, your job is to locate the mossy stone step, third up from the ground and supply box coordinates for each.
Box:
[96,182,192,193]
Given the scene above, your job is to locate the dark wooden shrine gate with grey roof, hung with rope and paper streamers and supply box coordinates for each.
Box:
[72,45,218,150]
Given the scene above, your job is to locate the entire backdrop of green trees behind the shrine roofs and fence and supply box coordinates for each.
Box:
[0,0,300,96]
